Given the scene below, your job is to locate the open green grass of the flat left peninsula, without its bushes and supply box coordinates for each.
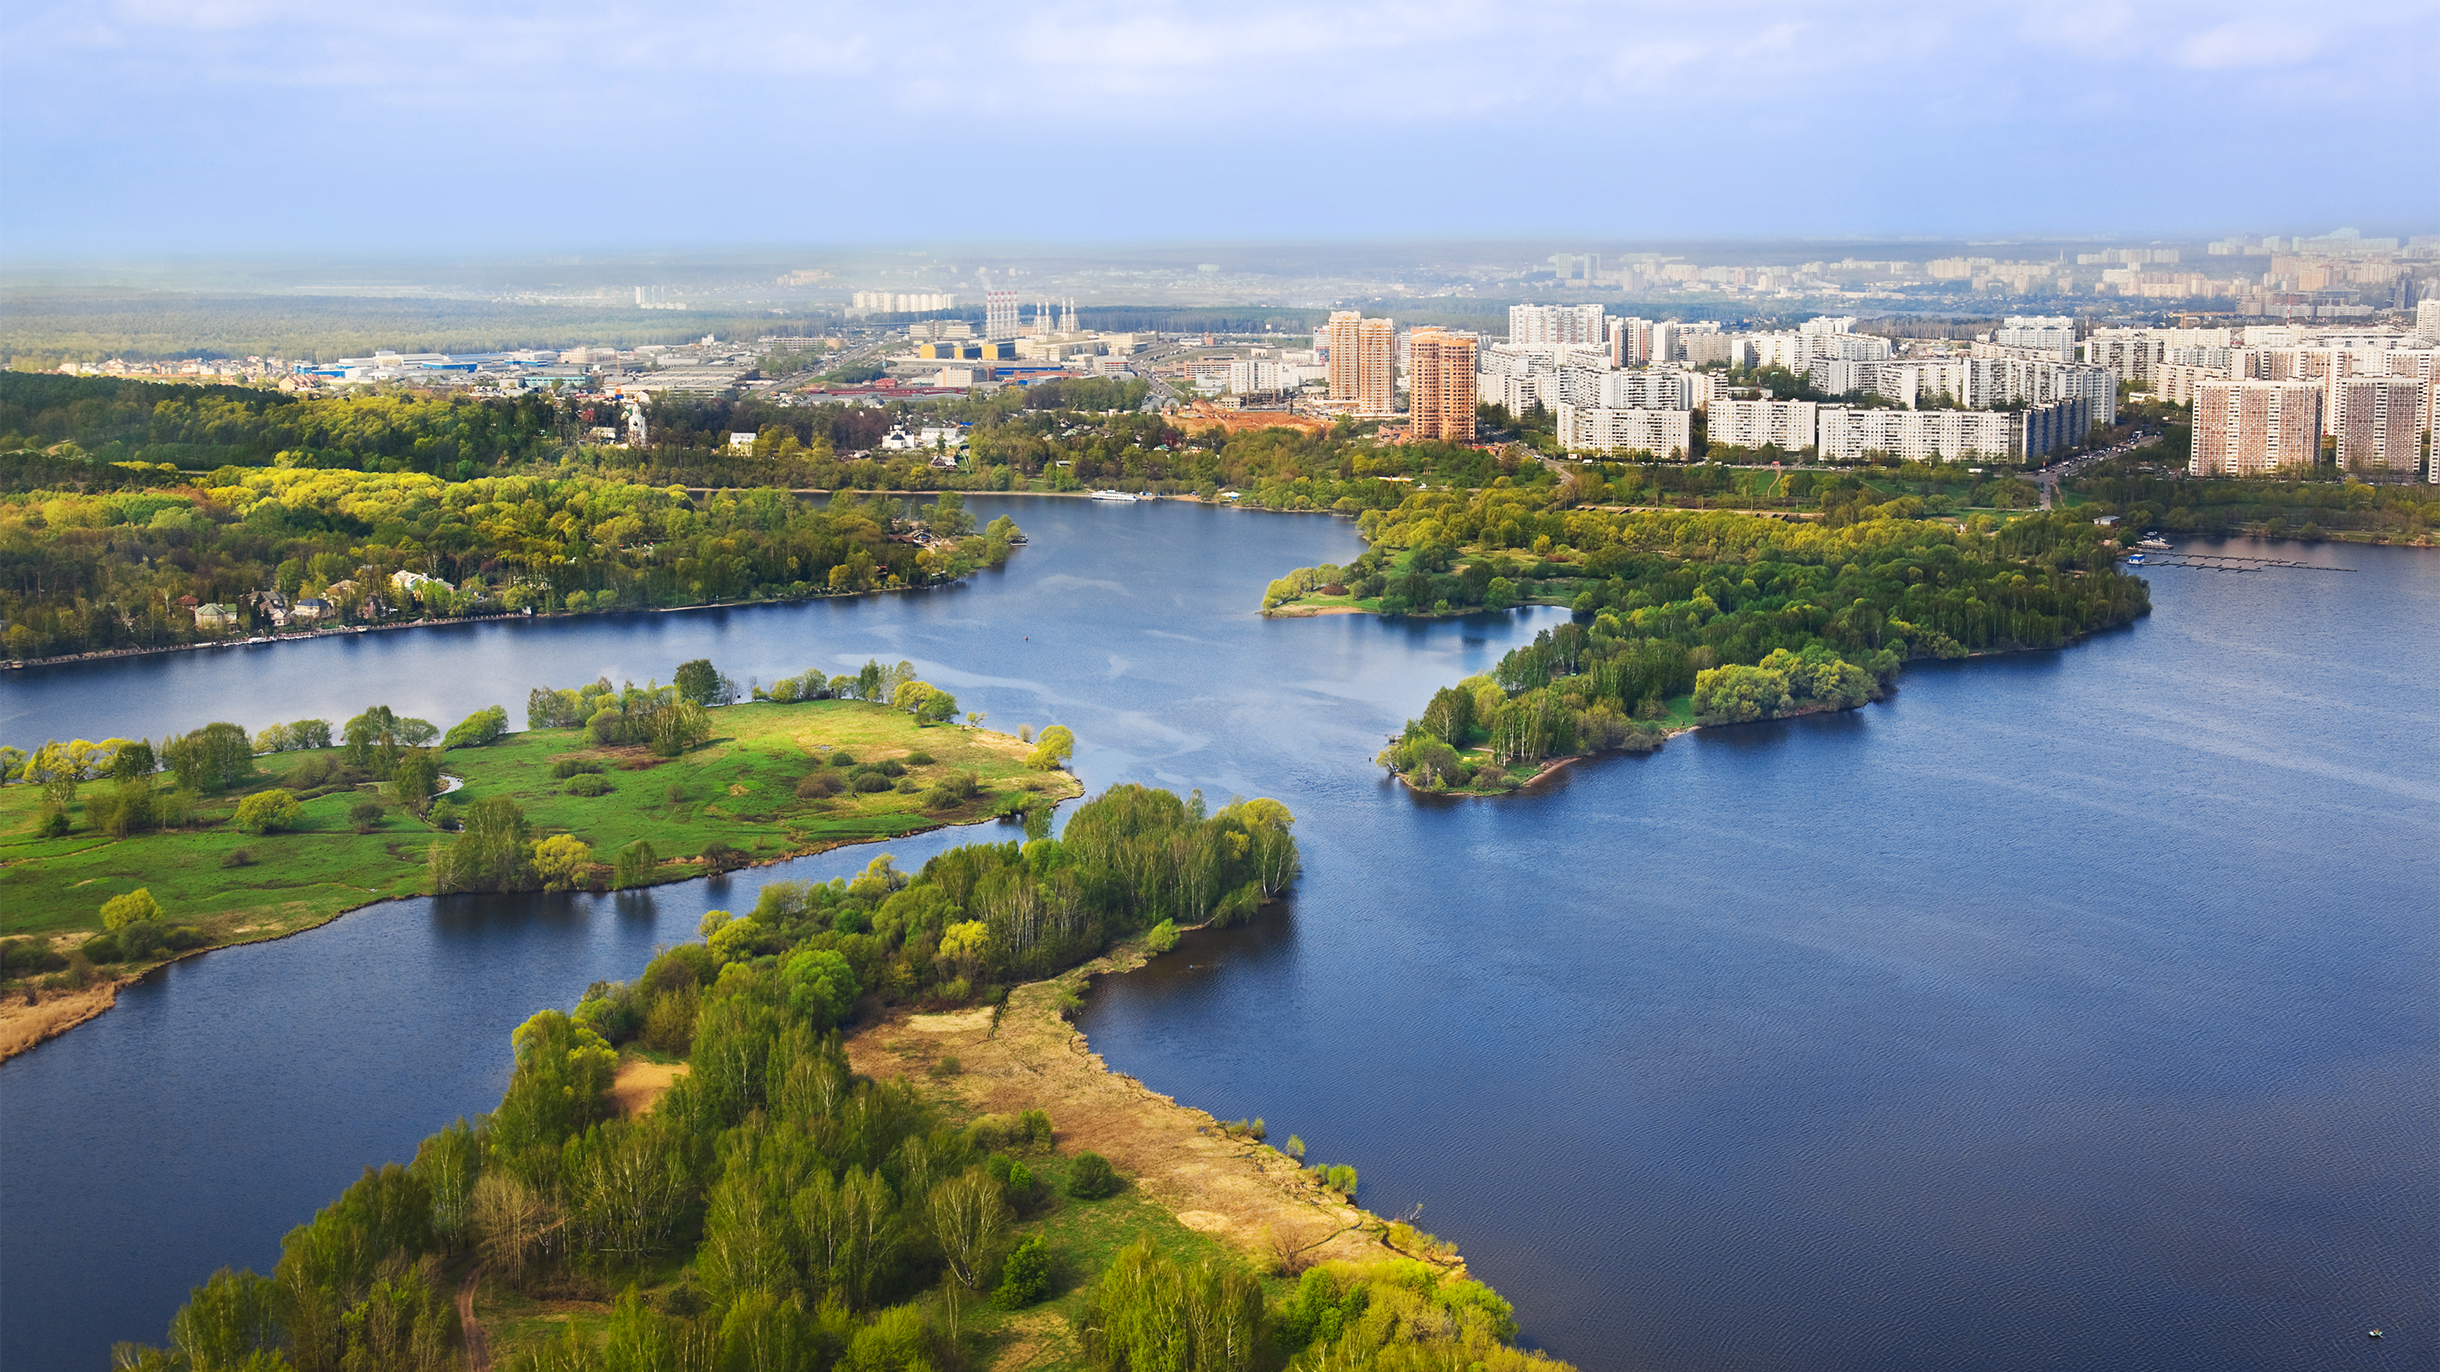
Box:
[0,701,1081,950]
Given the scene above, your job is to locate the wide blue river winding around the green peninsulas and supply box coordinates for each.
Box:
[0,500,2440,1372]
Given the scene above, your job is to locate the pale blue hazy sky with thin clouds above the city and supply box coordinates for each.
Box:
[0,0,2440,261]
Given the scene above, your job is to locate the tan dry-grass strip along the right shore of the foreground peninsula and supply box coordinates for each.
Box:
[847,937,1464,1272]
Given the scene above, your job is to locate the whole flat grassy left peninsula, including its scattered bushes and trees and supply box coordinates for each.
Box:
[0,662,1083,1030]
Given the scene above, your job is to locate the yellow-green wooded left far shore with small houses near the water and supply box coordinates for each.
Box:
[0,469,1017,659]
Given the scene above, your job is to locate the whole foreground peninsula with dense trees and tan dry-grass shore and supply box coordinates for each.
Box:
[100,786,1564,1372]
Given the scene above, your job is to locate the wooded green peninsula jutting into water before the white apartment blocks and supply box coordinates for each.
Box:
[1264,486,2150,793]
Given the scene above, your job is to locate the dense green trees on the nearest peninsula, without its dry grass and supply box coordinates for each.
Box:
[117,786,1549,1372]
